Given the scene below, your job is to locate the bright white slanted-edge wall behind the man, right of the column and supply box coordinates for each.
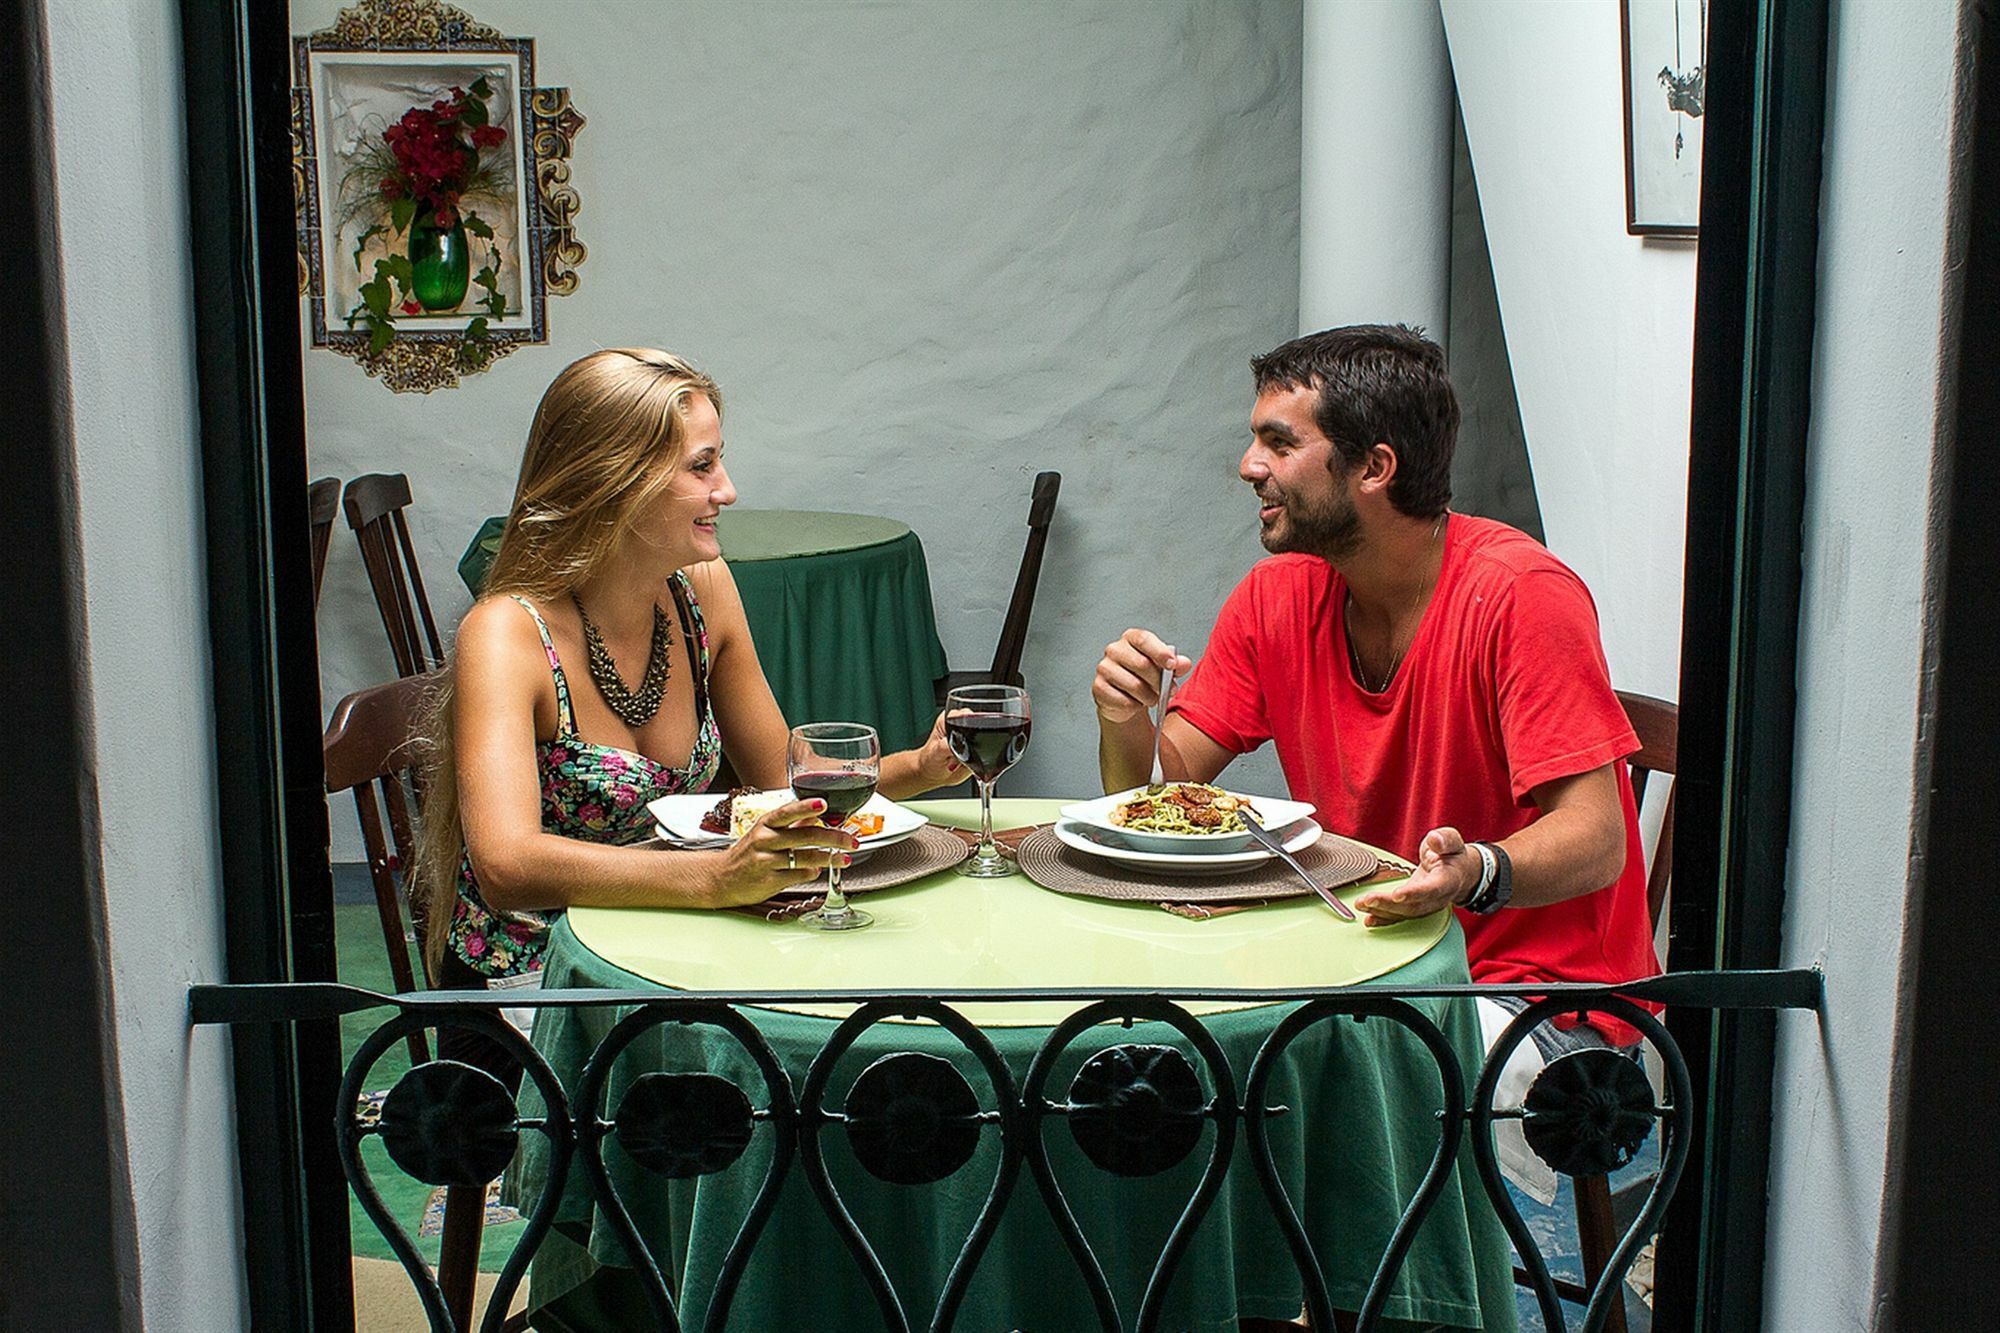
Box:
[1442,0,1694,699]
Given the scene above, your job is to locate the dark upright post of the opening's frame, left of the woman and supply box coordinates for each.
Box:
[180,0,354,1329]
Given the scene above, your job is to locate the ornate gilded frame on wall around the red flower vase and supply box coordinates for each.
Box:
[292,0,586,392]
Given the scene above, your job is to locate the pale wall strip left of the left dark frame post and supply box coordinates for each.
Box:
[46,0,244,1331]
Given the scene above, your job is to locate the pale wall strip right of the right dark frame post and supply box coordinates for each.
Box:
[1764,0,1960,1331]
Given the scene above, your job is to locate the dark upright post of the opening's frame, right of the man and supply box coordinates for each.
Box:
[1654,0,1828,1329]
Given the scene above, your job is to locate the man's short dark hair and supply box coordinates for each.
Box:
[1250,324,1458,518]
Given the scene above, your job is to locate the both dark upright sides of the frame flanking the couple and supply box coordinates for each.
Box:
[182,0,1826,1329]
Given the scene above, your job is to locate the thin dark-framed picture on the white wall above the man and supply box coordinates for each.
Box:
[1618,0,1708,236]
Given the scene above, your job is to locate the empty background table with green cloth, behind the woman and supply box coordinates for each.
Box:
[458,508,946,751]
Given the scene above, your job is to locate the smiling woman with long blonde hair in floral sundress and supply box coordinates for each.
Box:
[418,348,964,987]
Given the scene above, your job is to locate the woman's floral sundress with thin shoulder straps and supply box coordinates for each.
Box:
[448,572,722,977]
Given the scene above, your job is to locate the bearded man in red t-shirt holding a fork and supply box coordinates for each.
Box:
[1092,326,1660,1055]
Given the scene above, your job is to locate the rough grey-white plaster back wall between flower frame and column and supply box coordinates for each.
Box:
[292,0,1300,859]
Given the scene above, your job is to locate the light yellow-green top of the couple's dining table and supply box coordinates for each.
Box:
[568,799,1448,1027]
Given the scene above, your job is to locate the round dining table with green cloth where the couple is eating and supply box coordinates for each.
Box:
[508,801,1514,1331]
